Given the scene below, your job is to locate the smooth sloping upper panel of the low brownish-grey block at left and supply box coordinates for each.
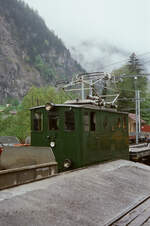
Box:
[0,146,56,170]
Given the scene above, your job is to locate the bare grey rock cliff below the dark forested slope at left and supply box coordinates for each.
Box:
[0,17,45,102]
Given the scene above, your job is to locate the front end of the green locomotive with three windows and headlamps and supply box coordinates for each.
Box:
[31,105,80,170]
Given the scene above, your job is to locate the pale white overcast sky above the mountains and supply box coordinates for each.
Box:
[24,0,150,70]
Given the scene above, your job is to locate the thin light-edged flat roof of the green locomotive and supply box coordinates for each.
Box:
[30,103,128,114]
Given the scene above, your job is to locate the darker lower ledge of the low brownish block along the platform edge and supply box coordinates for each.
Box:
[0,162,58,190]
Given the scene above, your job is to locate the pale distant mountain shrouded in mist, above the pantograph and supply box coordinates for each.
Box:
[70,39,130,72]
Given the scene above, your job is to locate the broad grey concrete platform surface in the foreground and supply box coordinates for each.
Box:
[0,160,150,226]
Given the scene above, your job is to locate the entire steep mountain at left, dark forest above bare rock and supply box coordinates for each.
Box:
[0,0,83,102]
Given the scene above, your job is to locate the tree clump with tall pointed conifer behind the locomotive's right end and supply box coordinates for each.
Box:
[110,54,147,112]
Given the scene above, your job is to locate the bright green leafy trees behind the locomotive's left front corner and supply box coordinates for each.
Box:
[0,87,68,142]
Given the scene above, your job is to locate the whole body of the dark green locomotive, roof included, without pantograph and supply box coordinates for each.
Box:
[31,101,129,171]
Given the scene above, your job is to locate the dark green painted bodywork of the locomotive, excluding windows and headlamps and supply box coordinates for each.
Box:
[31,105,129,170]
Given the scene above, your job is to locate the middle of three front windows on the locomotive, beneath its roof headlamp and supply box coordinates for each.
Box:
[48,111,59,130]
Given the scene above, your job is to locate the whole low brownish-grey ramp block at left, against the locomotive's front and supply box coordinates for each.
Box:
[0,146,58,189]
